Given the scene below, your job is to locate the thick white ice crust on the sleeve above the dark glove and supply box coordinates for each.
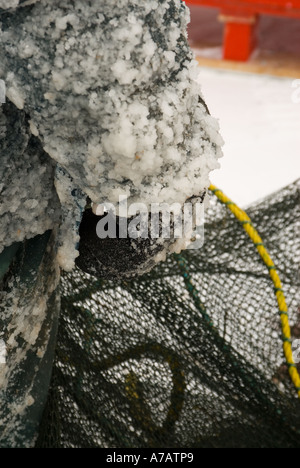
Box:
[0,0,222,269]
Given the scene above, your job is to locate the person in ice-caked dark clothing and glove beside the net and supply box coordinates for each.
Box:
[0,0,222,446]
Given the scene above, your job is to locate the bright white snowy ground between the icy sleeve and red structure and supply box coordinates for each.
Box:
[199,68,300,206]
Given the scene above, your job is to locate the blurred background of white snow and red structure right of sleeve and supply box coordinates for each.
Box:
[186,0,300,207]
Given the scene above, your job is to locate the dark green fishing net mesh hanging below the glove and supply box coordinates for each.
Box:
[36,180,300,448]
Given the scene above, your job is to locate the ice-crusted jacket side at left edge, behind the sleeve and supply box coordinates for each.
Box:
[0,103,60,253]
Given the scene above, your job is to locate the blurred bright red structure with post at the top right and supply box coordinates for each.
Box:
[185,0,300,61]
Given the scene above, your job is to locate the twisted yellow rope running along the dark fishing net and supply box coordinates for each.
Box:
[209,185,300,398]
